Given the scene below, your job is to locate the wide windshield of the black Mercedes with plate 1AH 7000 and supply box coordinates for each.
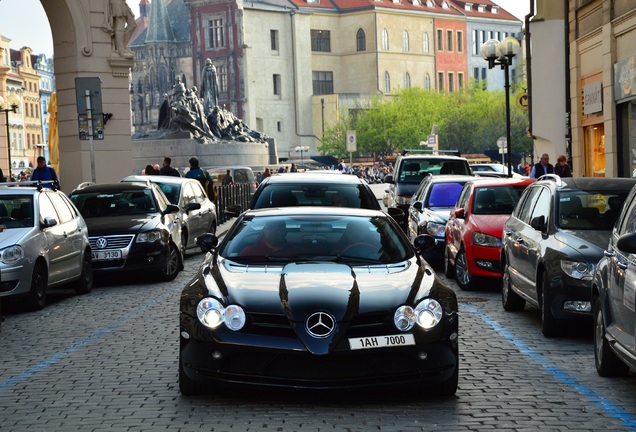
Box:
[219,215,413,265]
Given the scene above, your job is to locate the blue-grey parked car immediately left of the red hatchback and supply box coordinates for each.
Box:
[407,175,475,262]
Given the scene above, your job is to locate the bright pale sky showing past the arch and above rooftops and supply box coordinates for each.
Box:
[0,0,530,57]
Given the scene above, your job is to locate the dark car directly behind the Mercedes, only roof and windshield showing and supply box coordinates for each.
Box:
[226,171,381,216]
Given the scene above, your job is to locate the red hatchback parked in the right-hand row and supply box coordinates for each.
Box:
[444,177,535,290]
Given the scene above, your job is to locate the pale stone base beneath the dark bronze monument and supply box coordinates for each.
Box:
[132,136,276,174]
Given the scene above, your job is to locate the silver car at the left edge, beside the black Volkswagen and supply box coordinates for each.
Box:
[0,182,93,310]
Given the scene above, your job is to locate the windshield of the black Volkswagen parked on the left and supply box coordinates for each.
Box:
[71,189,158,219]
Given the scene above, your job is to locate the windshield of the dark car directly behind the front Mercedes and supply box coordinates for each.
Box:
[253,183,377,209]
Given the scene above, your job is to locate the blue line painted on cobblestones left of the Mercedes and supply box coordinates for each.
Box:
[0,287,182,392]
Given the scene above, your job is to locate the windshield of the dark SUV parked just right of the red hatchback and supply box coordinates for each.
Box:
[557,190,627,230]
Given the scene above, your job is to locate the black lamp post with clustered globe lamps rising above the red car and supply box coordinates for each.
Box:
[479,36,519,177]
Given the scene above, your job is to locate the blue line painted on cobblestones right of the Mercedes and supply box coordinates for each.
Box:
[462,303,636,430]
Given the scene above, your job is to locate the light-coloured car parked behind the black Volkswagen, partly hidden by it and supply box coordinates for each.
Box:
[121,175,217,254]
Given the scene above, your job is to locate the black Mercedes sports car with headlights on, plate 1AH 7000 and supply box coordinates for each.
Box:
[179,207,459,395]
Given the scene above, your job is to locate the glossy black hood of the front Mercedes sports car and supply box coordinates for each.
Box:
[196,258,457,355]
